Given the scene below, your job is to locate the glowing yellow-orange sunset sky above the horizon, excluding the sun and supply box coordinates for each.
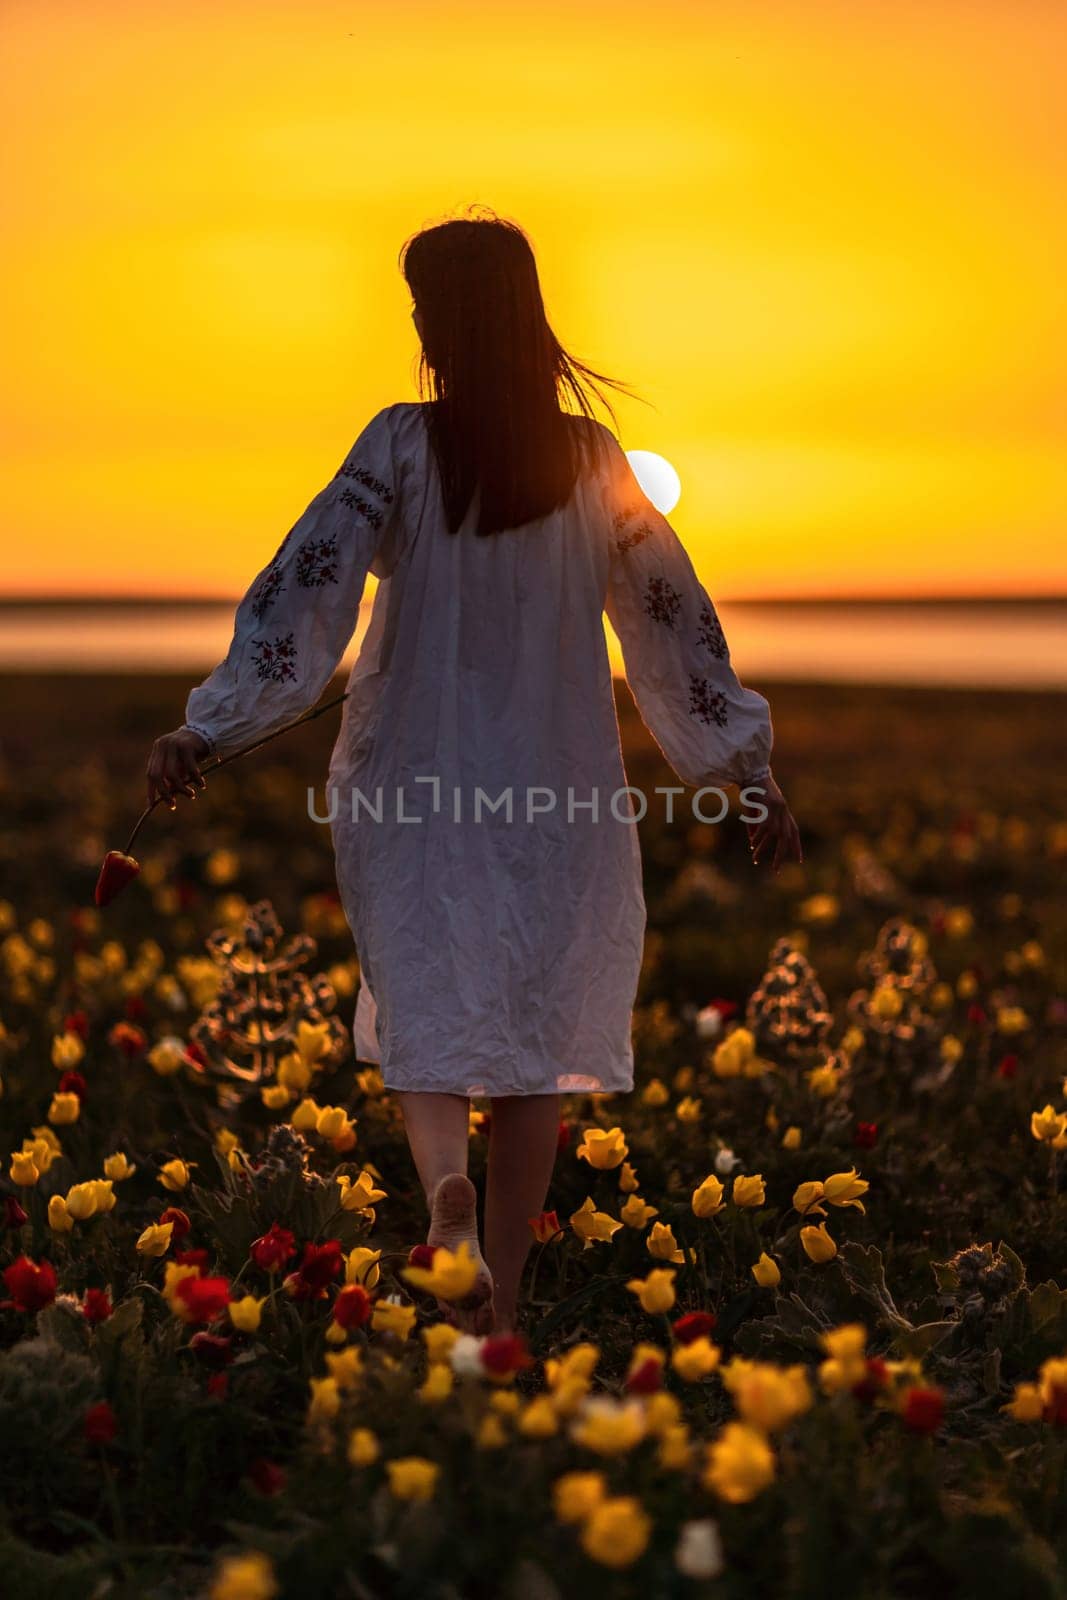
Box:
[0,0,1067,598]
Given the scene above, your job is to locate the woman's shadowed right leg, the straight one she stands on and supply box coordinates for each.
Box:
[485,1093,560,1333]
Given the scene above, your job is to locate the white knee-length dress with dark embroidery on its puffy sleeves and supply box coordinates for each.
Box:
[186,402,771,1096]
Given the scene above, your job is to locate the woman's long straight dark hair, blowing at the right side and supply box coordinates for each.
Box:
[400,208,640,536]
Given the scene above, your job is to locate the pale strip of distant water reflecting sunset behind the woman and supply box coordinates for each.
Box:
[0,600,1067,690]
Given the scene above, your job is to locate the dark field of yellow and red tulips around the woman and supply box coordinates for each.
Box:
[0,680,1067,1600]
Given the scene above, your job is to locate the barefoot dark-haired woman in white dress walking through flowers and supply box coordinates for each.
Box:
[147,216,800,1333]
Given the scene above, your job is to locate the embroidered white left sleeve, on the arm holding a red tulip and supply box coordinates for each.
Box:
[186,406,400,755]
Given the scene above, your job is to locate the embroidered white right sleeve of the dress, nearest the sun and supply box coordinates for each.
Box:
[603,429,773,787]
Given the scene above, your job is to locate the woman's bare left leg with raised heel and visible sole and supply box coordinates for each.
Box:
[397,1091,493,1333]
